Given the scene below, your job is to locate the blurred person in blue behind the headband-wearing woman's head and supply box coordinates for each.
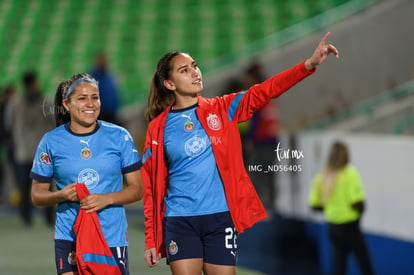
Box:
[90,53,120,124]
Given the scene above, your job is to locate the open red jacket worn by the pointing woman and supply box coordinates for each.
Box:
[142,62,315,257]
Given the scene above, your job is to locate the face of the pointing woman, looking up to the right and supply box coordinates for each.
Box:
[164,53,203,106]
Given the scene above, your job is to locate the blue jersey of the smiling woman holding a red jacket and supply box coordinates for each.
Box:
[30,121,142,247]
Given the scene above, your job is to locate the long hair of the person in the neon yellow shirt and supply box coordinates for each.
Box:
[321,141,349,203]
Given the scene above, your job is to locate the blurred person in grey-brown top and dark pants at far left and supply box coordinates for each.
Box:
[11,71,55,227]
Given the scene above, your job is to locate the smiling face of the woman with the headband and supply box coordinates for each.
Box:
[63,83,101,133]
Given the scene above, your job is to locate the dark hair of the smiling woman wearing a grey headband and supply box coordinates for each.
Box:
[54,74,93,127]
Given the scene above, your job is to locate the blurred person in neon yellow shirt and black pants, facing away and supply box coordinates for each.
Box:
[309,141,374,275]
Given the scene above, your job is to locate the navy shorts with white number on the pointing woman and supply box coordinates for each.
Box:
[164,212,238,266]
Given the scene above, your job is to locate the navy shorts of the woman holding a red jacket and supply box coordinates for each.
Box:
[55,240,129,275]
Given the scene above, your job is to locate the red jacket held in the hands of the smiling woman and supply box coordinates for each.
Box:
[73,183,121,275]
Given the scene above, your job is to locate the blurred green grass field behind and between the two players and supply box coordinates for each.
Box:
[0,207,260,275]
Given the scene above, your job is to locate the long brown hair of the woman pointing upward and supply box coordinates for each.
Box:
[145,51,184,122]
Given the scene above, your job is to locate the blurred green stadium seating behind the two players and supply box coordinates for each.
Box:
[0,0,366,103]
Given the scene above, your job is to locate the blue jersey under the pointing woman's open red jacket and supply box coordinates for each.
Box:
[164,105,229,217]
